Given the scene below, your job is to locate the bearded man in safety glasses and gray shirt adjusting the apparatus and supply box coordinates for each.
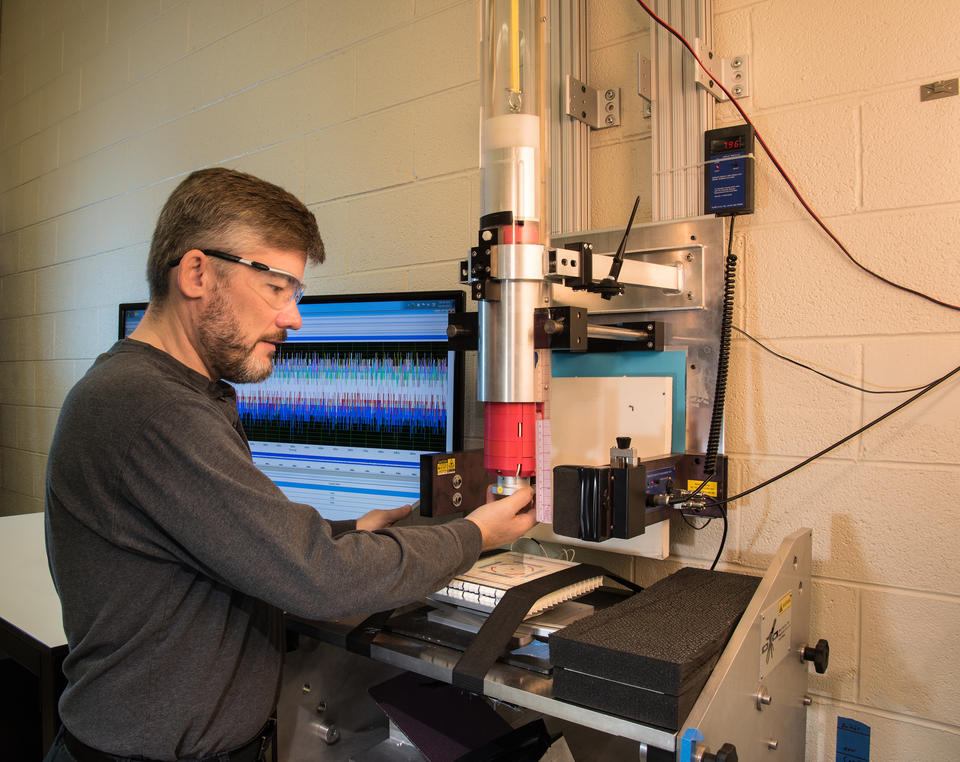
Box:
[46,169,534,762]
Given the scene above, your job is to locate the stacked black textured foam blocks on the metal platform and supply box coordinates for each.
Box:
[550,567,760,726]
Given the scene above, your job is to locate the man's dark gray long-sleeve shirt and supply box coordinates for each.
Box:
[46,339,481,760]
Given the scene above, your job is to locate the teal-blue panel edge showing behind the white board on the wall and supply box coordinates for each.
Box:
[550,350,687,452]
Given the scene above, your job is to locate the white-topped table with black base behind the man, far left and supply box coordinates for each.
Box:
[0,513,67,750]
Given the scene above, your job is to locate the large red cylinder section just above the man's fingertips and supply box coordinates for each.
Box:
[483,402,537,477]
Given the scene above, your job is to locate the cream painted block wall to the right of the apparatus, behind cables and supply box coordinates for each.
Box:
[664,0,960,762]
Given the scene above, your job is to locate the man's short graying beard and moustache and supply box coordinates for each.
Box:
[197,288,287,384]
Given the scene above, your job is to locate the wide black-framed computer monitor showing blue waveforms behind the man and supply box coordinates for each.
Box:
[120,291,465,521]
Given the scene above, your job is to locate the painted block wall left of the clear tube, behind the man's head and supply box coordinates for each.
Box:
[0,0,488,514]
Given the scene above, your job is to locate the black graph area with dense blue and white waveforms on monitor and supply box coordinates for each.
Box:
[237,342,450,451]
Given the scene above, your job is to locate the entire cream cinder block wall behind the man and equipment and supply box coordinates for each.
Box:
[0,0,960,761]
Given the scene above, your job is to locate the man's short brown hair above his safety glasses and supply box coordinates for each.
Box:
[147,168,324,304]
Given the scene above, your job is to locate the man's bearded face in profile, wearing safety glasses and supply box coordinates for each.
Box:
[197,246,306,384]
